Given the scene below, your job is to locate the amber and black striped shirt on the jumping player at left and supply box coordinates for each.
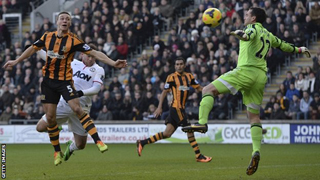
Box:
[33,31,92,81]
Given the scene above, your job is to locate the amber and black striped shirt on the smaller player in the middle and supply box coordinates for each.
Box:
[164,72,200,109]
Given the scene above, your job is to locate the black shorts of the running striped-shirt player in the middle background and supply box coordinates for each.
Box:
[165,107,191,129]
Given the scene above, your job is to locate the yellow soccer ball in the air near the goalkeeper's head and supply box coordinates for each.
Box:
[202,8,221,27]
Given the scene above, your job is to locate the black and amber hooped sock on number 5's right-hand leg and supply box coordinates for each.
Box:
[79,113,101,144]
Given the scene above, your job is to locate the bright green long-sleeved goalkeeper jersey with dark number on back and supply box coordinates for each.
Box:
[238,23,298,72]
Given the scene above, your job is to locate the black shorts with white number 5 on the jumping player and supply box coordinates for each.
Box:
[41,78,78,104]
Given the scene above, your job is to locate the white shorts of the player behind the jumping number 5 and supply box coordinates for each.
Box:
[42,100,90,136]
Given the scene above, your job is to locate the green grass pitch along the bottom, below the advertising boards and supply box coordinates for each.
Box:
[6,144,320,180]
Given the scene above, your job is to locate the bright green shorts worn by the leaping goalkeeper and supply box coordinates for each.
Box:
[212,67,267,114]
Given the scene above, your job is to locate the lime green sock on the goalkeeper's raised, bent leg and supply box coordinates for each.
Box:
[199,94,214,124]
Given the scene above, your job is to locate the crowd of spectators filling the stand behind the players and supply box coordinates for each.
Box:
[0,0,320,124]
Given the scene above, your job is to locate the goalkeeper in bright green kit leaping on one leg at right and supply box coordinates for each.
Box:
[182,7,310,175]
